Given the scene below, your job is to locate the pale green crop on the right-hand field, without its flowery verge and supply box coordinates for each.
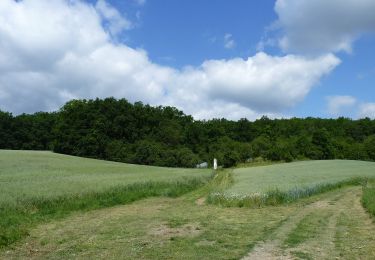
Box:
[227,160,375,195]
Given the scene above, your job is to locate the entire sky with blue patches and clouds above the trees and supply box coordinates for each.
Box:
[0,0,375,120]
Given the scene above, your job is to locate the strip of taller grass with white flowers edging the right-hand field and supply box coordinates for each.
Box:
[207,178,367,208]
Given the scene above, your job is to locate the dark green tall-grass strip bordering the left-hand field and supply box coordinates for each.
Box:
[0,177,210,248]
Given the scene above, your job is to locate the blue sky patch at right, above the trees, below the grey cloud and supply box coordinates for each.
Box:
[298,33,375,118]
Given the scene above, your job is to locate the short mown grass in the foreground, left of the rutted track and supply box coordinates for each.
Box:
[0,187,300,259]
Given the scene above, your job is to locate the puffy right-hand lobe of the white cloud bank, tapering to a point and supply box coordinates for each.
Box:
[176,53,340,112]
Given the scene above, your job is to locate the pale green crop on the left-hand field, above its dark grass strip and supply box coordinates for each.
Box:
[0,150,211,205]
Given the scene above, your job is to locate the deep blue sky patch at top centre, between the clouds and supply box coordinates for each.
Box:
[122,0,276,67]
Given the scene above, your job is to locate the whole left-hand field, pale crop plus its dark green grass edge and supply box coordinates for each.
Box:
[0,151,211,247]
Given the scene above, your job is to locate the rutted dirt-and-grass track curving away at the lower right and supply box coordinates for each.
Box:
[243,187,375,260]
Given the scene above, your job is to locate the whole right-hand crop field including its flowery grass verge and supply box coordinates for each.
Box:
[208,160,375,207]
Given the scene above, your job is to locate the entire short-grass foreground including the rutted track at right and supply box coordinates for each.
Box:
[0,187,375,260]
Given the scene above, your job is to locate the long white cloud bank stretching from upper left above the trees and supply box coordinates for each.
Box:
[0,0,340,119]
